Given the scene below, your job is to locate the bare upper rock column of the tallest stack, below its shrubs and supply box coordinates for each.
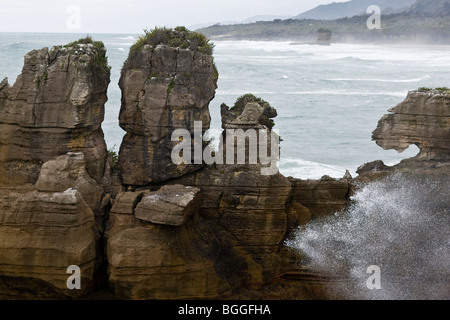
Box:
[119,38,217,186]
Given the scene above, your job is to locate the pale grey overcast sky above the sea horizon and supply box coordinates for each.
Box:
[0,0,345,33]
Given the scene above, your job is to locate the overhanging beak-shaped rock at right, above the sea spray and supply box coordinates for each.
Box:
[357,88,450,182]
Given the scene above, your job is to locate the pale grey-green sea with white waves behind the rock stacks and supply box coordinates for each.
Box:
[0,33,450,179]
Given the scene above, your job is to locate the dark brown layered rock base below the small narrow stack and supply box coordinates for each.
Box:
[171,165,294,287]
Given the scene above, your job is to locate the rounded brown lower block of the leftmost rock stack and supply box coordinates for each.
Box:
[0,184,98,298]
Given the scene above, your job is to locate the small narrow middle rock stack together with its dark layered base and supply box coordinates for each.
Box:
[162,95,298,290]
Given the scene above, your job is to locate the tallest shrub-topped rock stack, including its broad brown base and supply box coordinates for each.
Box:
[106,28,226,299]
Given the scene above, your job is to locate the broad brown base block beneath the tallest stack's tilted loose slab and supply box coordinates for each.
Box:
[106,186,228,299]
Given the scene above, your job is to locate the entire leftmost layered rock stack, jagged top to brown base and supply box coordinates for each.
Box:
[0,38,110,298]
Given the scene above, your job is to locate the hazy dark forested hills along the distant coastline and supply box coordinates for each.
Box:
[198,0,450,44]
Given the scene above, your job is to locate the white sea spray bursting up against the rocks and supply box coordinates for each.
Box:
[286,173,450,299]
